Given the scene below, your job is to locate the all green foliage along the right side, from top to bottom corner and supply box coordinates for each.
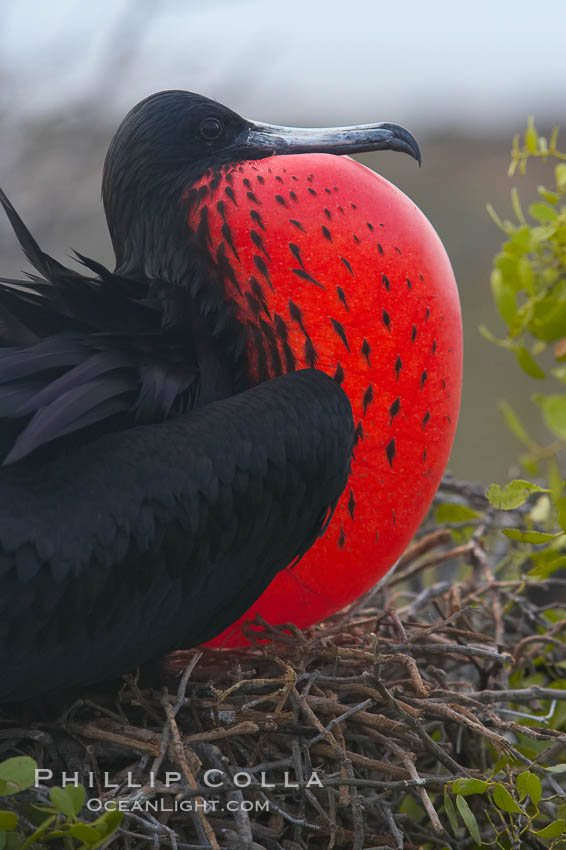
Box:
[430,119,566,848]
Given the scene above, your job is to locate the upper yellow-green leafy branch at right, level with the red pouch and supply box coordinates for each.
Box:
[481,118,566,578]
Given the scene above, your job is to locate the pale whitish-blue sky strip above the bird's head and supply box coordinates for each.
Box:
[0,0,566,128]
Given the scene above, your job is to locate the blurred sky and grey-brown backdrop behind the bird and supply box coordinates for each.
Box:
[0,0,566,482]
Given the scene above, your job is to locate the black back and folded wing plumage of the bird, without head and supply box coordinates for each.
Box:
[0,195,353,701]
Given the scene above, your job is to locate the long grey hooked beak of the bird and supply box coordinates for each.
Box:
[236,121,421,165]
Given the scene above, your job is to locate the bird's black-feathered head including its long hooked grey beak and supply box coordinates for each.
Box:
[102,91,420,272]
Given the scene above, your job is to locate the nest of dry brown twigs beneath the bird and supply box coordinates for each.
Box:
[0,481,566,850]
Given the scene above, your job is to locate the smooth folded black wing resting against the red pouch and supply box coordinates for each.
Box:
[0,370,353,700]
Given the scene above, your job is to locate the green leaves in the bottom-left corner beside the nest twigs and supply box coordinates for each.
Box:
[0,756,123,850]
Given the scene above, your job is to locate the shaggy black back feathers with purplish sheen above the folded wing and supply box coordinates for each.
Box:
[0,190,204,464]
